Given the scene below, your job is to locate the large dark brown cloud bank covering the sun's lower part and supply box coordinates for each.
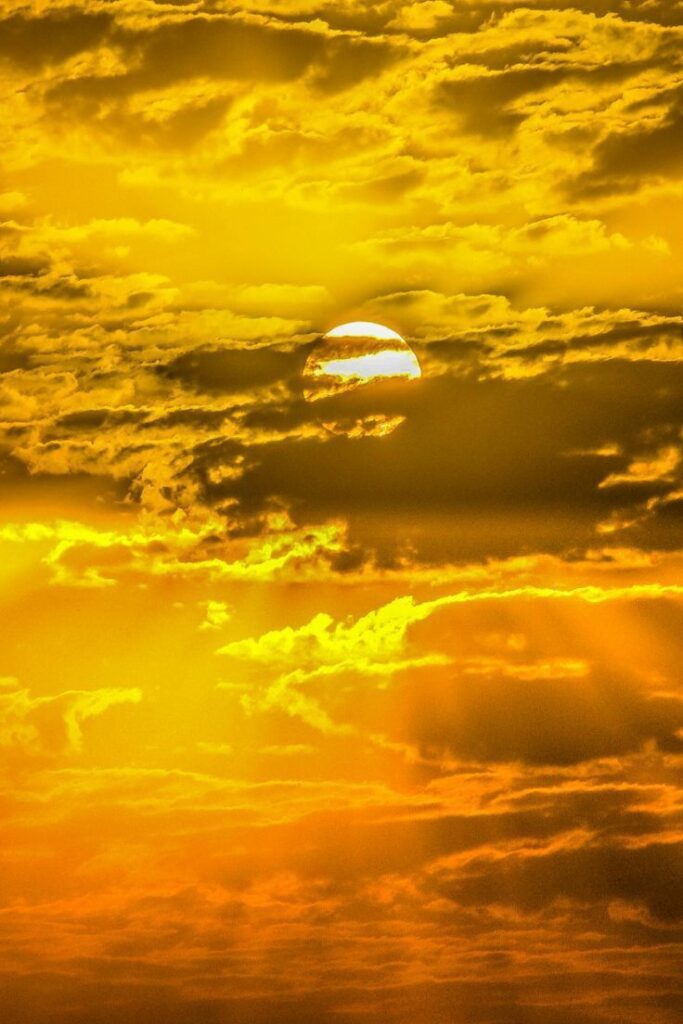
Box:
[195,357,683,556]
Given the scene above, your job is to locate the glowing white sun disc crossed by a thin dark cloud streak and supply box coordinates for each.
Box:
[303,321,422,401]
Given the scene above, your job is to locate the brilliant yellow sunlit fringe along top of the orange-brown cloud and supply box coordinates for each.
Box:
[217,584,683,746]
